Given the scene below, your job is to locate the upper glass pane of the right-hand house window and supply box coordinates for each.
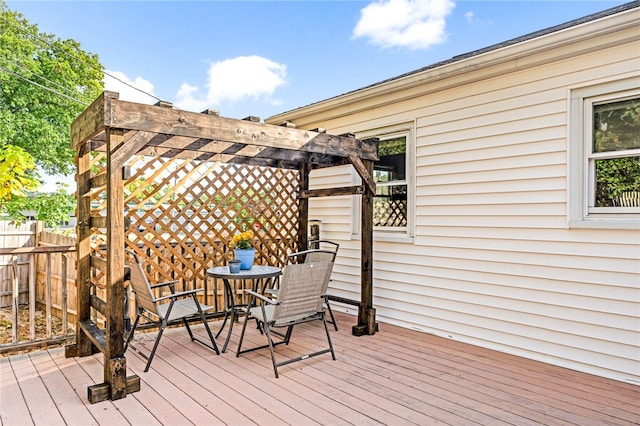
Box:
[593,98,640,152]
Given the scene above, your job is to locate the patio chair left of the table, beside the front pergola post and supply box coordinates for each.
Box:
[124,254,220,372]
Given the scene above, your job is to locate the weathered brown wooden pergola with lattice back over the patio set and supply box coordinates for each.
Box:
[65,92,378,402]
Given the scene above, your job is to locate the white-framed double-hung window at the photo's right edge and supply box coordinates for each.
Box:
[569,80,640,227]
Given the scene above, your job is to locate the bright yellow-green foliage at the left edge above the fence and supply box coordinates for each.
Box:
[0,145,40,204]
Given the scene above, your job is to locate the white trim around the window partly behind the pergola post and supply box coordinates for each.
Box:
[352,121,416,242]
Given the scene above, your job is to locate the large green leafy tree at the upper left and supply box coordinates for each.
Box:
[0,0,104,174]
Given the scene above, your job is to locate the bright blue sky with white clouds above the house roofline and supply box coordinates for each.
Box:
[6,0,625,189]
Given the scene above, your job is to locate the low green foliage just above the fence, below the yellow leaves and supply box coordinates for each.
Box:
[3,185,76,228]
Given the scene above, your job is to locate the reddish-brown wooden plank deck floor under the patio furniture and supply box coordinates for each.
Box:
[0,314,640,426]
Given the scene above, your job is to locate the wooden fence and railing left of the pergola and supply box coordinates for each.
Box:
[0,221,76,353]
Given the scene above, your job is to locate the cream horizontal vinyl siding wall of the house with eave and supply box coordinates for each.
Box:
[272,9,640,384]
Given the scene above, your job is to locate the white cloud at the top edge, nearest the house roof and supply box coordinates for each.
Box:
[353,0,455,49]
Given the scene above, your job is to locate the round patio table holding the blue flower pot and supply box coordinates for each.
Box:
[207,265,282,352]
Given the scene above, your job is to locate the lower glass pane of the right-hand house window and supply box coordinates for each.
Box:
[595,157,640,207]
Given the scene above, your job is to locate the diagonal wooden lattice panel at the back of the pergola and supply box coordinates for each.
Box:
[119,152,299,288]
